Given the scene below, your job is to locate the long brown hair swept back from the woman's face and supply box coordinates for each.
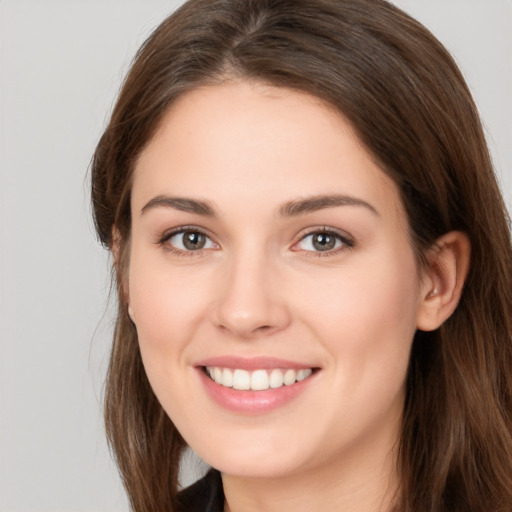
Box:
[92,0,512,512]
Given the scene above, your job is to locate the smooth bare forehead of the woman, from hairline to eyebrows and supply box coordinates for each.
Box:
[132,82,400,220]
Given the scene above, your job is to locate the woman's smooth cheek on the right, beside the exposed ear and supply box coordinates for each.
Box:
[307,244,419,384]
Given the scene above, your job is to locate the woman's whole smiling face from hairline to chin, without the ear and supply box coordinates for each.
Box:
[127,82,424,477]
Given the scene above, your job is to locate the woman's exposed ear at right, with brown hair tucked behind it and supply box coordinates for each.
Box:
[417,231,471,331]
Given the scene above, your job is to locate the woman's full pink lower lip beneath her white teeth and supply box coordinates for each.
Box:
[198,368,317,414]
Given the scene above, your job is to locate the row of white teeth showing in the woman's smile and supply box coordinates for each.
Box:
[206,367,313,391]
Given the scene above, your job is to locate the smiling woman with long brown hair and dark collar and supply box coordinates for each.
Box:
[92,0,512,512]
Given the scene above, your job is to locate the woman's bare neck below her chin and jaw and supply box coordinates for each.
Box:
[222,436,399,512]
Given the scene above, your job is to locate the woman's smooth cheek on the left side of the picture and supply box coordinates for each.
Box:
[129,248,218,424]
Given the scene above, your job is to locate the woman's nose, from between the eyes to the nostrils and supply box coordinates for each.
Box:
[214,255,291,339]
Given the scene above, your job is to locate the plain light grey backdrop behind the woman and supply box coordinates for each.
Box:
[0,0,512,512]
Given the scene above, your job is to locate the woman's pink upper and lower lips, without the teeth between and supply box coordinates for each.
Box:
[194,356,320,415]
